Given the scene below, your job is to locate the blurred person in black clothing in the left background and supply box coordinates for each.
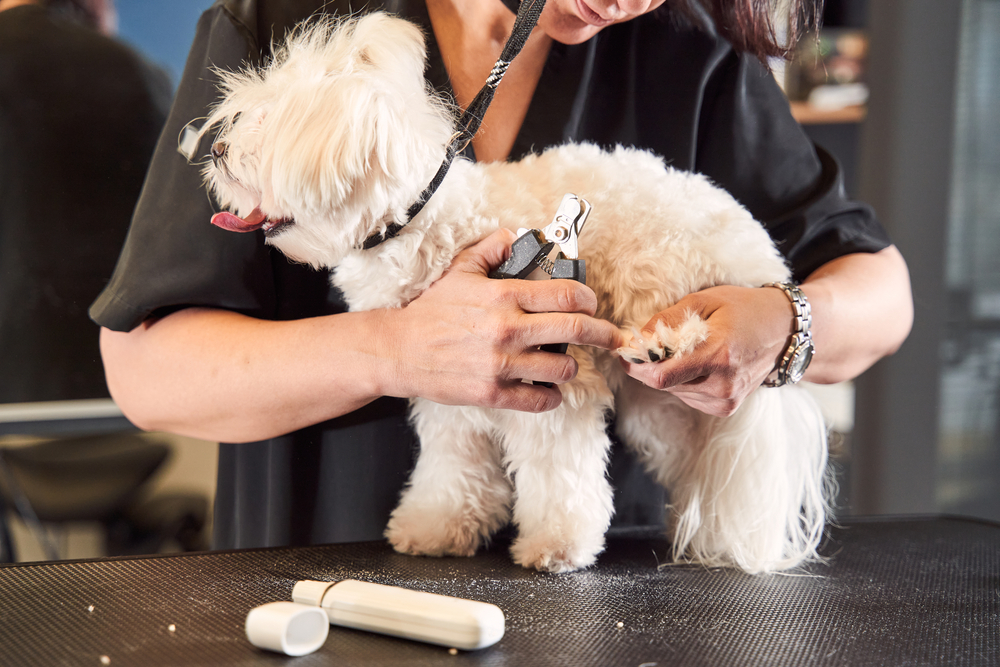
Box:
[0,0,172,403]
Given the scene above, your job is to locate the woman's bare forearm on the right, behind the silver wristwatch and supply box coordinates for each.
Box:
[802,246,913,384]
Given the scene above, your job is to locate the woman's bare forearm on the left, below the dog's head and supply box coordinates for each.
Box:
[101,308,380,442]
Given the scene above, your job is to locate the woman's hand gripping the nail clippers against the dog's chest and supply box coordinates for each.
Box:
[376,230,623,412]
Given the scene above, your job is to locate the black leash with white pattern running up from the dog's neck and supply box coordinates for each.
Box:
[361,0,545,250]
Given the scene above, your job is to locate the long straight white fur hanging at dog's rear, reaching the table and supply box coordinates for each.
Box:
[671,387,835,573]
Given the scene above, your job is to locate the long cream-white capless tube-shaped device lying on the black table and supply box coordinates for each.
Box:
[292,579,504,650]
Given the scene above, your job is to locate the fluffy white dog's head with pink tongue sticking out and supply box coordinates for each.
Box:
[202,13,454,267]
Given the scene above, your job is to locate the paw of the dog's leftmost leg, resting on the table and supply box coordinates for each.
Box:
[385,508,486,556]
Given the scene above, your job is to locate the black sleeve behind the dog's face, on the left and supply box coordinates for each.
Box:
[90,3,275,331]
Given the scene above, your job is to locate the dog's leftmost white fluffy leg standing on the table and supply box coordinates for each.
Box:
[385,399,511,556]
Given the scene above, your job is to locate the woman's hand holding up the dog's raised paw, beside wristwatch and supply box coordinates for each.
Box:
[621,286,792,417]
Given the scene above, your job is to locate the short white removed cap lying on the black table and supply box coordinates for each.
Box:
[246,602,330,655]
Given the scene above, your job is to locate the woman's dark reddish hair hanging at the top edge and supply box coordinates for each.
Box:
[667,0,823,60]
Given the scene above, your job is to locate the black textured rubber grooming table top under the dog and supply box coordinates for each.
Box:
[0,518,1000,667]
